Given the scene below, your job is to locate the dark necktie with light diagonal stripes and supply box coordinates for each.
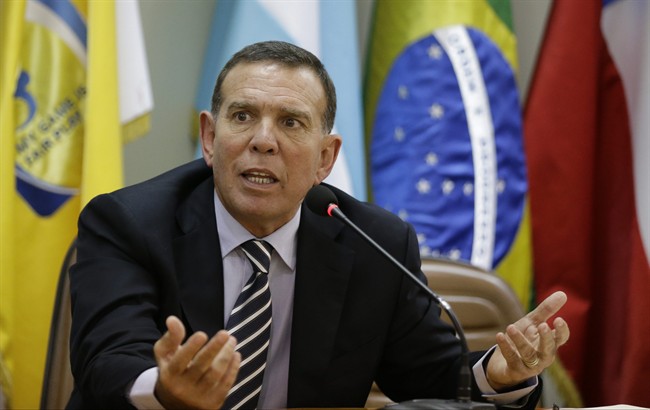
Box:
[223,240,273,410]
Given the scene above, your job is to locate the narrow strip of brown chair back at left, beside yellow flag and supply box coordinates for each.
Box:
[41,243,77,409]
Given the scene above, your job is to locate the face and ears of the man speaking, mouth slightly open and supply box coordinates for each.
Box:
[201,62,341,237]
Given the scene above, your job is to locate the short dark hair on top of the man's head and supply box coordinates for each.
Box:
[211,41,336,134]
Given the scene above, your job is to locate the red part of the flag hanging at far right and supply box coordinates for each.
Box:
[524,0,650,406]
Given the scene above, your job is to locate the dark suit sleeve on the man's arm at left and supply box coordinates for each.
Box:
[70,195,175,408]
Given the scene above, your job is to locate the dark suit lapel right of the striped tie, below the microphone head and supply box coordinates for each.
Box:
[288,203,354,405]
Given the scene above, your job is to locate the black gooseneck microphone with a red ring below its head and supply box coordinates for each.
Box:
[305,185,495,410]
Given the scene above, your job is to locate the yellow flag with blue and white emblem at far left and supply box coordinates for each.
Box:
[0,0,152,408]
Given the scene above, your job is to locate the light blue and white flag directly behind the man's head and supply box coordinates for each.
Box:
[195,0,366,200]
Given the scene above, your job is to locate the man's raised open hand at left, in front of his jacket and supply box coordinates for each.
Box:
[153,316,241,409]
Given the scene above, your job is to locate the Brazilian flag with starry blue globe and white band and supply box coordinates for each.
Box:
[364,0,532,307]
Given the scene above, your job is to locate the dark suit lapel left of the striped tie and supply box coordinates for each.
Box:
[173,178,224,336]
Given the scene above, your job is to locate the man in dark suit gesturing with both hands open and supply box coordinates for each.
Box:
[69,42,569,408]
